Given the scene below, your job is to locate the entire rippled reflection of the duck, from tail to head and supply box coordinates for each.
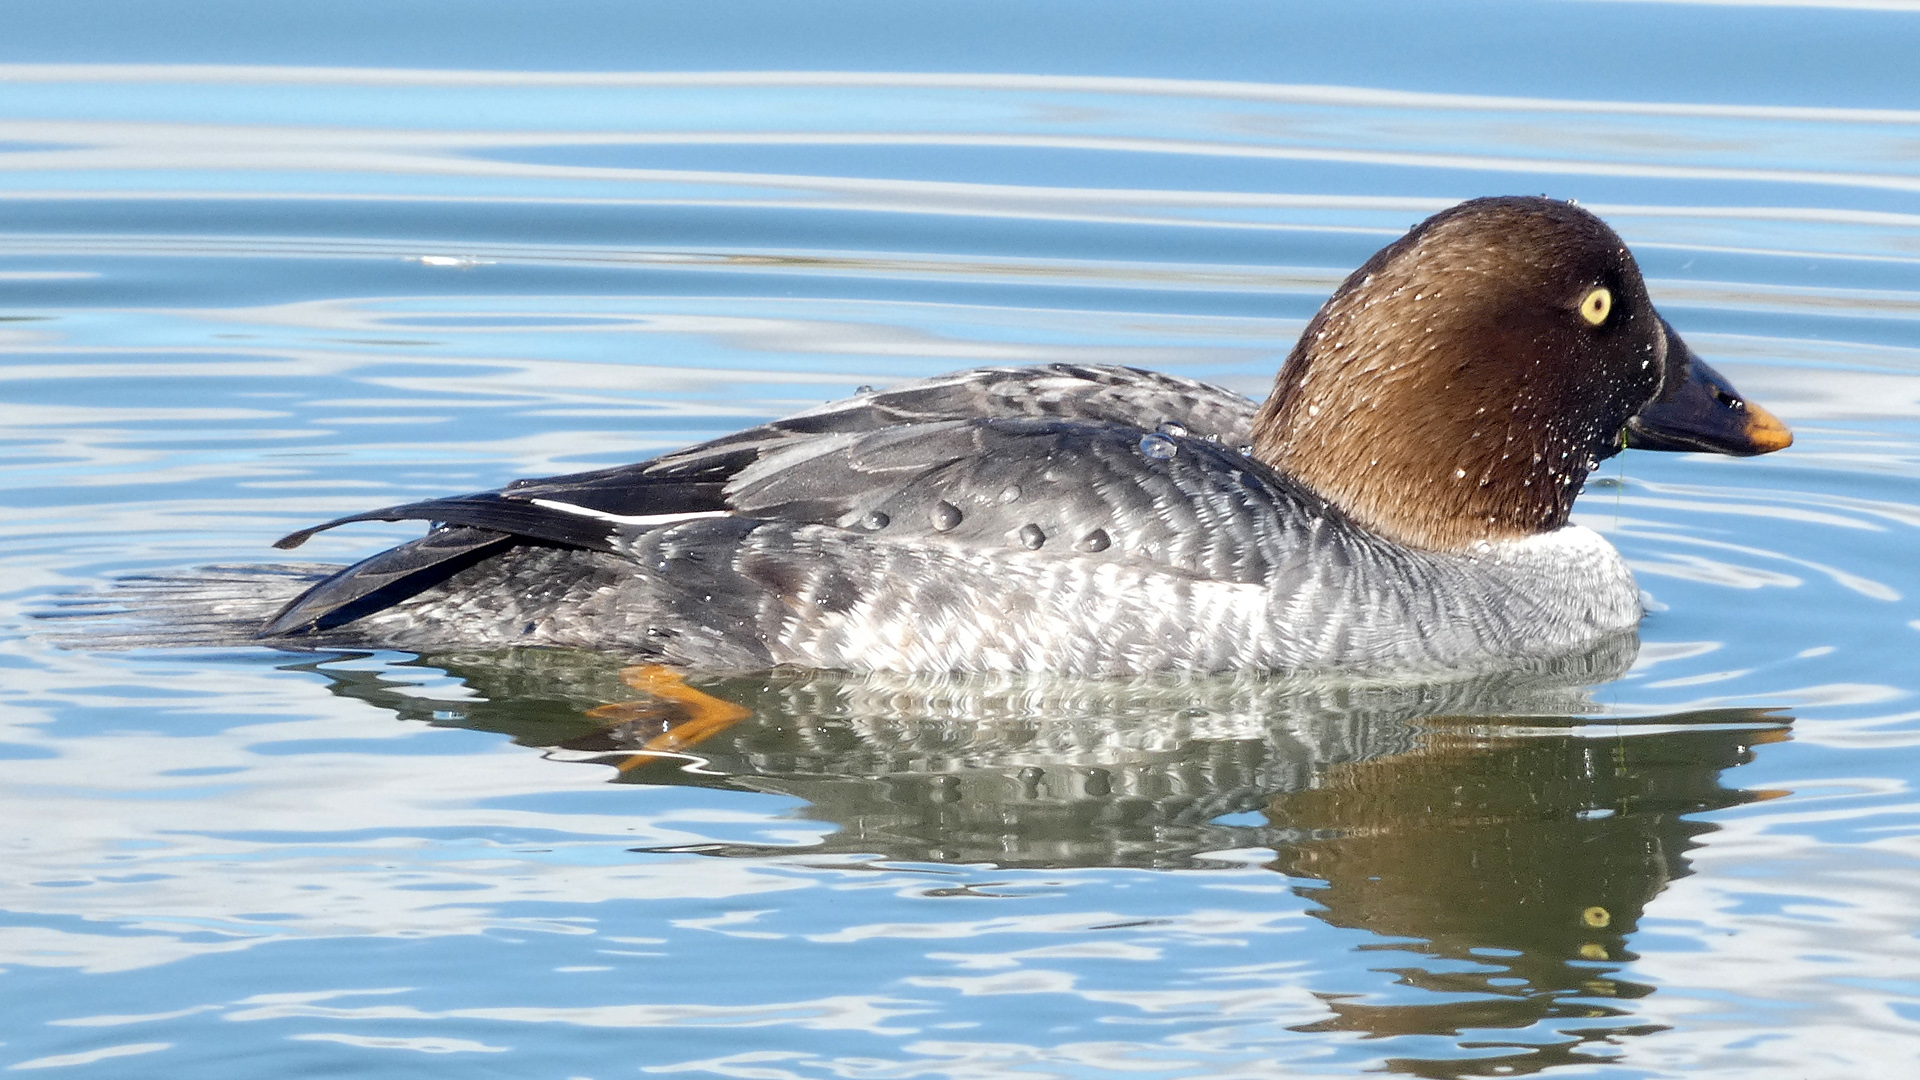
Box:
[295,640,1788,1076]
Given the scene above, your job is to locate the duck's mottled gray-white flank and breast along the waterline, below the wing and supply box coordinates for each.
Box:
[341,503,1640,675]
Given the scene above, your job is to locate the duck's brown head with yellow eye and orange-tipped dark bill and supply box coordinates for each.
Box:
[1254,196,1793,550]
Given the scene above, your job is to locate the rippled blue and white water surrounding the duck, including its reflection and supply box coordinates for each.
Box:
[0,0,1920,1078]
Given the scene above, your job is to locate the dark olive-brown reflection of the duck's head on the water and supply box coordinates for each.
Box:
[1267,709,1786,1076]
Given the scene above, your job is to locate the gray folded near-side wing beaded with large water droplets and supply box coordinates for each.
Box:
[714,411,1348,584]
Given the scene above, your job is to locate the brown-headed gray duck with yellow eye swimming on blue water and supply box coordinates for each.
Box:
[257,196,1793,676]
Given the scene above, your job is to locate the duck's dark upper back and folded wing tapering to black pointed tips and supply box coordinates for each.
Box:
[263,365,1254,636]
